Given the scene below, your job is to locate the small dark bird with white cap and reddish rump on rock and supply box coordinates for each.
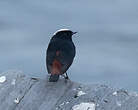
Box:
[46,29,77,82]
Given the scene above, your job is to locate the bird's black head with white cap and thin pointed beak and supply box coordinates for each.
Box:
[53,29,77,39]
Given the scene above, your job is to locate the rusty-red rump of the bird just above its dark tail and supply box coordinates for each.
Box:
[51,59,61,74]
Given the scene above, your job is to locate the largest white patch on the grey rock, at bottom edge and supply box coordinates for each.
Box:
[72,103,95,110]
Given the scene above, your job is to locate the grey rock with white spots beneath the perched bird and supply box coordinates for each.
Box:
[0,71,138,110]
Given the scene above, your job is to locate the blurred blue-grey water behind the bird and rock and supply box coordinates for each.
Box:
[0,0,138,90]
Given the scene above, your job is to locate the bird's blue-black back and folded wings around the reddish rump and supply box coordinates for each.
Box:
[46,37,76,74]
